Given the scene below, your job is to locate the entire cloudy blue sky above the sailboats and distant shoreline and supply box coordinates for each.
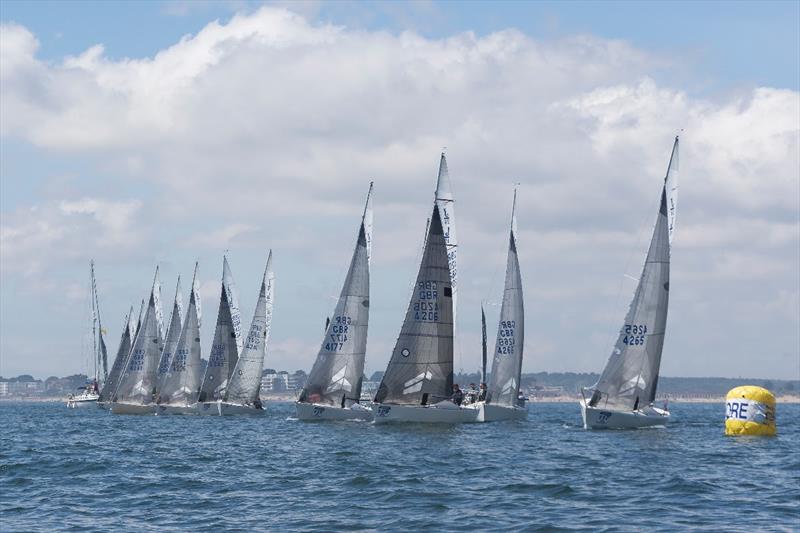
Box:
[0,0,800,379]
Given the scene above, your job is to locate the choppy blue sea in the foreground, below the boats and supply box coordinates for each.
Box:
[0,403,800,531]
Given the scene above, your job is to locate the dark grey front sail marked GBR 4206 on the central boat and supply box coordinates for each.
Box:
[375,204,453,405]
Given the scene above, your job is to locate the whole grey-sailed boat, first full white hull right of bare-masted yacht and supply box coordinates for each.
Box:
[111,267,164,414]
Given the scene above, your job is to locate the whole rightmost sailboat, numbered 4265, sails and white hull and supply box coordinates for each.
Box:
[580,137,678,429]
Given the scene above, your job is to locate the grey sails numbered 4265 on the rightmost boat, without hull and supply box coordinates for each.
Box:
[589,137,678,410]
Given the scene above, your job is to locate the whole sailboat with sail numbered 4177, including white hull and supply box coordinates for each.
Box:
[295,183,372,420]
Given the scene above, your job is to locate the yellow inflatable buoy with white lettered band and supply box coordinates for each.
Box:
[725,385,776,436]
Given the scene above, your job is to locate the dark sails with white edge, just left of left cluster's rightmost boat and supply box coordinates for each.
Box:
[199,257,242,402]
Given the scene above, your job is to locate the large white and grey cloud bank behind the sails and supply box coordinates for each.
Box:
[0,5,800,374]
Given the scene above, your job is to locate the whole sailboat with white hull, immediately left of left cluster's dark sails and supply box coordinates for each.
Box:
[156,263,202,414]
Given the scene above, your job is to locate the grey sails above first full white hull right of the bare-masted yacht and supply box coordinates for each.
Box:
[114,268,164,404]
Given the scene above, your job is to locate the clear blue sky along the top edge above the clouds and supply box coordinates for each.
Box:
[6,0,800,91]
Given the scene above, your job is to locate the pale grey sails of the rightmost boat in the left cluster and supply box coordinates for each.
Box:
[225,250,275,405]
